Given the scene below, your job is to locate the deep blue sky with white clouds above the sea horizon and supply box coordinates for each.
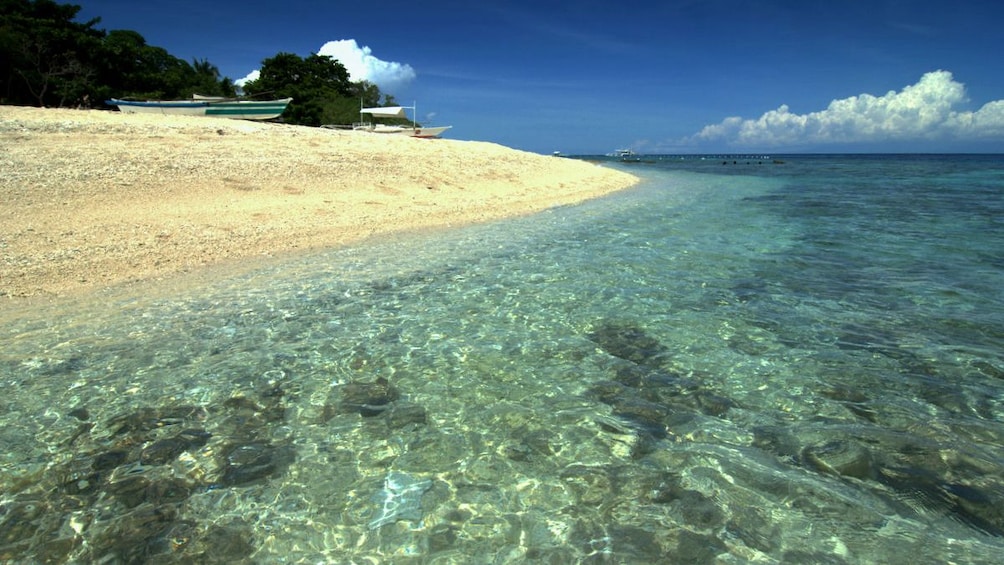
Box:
[78,0,1004,154]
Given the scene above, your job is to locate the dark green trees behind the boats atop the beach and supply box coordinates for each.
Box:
[0,0,395,125]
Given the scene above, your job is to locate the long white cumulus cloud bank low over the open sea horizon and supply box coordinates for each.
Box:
[687,70,1004,149]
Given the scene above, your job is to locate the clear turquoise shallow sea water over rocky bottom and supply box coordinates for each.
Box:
[0,156,1004,563]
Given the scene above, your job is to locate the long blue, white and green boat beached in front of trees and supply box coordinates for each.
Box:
[104,94,293,119]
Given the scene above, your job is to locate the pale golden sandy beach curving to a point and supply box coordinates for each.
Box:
[0,106,637,304]
